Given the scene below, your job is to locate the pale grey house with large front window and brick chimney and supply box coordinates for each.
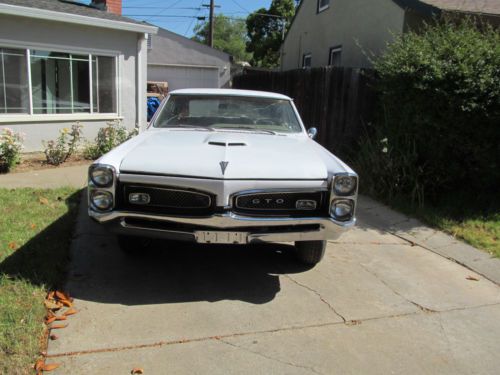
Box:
[0,0,157,151]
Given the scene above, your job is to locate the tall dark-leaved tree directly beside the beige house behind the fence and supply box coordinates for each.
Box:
[246,0,295,68]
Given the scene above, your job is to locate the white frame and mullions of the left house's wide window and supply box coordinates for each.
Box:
[0,38,122,123]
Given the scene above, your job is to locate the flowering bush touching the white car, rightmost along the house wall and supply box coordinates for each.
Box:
[83,121,138,160]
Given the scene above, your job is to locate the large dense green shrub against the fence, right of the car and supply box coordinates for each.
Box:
[355,19,500,205]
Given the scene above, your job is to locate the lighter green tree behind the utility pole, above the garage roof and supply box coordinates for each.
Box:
[192,14,252,61]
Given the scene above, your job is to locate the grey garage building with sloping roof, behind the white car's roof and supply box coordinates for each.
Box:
[148,29,231,90]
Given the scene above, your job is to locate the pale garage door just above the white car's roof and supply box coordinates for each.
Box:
[148,65,220,90]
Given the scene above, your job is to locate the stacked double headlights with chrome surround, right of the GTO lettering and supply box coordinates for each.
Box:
[329,173,358,223]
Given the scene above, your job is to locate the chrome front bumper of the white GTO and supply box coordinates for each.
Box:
[89,209,356,243]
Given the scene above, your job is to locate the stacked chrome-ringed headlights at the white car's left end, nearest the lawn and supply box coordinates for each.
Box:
[88,164,117,212]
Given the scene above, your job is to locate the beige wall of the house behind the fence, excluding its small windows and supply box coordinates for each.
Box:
[282,0,404,70]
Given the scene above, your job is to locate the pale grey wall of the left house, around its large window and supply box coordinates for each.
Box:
[0,15,147,152]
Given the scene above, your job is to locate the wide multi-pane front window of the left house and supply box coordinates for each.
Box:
[0,48,117,115]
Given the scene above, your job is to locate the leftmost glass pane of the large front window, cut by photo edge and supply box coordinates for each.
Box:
[0,48,29,114]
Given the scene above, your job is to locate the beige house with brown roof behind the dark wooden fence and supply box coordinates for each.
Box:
[281,0,500,70]
